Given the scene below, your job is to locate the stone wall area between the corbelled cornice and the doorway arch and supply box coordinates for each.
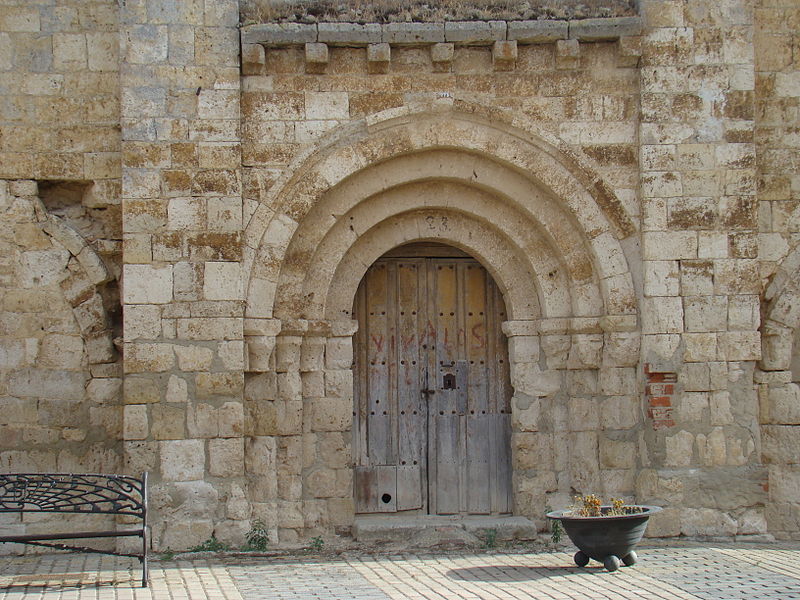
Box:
[242,34,638,223]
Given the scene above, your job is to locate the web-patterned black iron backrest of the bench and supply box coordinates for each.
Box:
[0,473,147,519]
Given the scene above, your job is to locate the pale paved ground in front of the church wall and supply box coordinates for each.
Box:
[0,543,800,600]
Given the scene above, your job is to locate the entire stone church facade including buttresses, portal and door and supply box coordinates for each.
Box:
[0,0,800,549]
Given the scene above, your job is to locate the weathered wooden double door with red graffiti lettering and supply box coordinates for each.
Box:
[353,249,512,515]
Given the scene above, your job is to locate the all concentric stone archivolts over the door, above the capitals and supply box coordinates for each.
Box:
[246,104,636,328]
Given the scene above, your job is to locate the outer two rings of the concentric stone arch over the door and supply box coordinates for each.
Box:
[245,104,636,326]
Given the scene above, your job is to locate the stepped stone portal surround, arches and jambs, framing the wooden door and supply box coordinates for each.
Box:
[243,103,639,539]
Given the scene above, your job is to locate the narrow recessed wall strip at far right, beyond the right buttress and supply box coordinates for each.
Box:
[754,1,800,538]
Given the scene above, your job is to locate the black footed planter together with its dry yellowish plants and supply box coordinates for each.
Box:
[547,494,661,571]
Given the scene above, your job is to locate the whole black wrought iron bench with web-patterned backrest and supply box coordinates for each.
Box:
[0,473,150,587]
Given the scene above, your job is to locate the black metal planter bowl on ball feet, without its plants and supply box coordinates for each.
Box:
[547,506,661,571]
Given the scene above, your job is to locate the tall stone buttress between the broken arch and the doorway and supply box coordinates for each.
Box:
[120,0,250,548]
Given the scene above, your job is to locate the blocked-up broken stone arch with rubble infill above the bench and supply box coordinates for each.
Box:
[0,181,122,472]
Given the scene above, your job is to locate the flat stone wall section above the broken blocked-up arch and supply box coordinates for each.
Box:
[0,0,120,182]
